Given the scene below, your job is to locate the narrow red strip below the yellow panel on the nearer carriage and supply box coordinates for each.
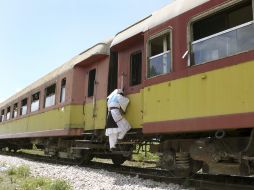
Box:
[143,112,254,134]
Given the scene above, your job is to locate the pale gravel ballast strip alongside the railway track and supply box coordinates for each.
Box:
[0,155,189,190]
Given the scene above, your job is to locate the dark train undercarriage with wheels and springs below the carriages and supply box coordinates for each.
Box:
[0,129,254,177]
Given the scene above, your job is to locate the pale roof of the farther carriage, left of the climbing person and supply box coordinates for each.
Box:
[0,37,113,107]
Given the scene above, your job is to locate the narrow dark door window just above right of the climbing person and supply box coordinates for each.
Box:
[130,52,142,86]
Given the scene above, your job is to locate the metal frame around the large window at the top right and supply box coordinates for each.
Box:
[186,0,254,67]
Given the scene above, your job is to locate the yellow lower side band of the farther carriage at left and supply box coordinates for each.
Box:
[0,105,84,139]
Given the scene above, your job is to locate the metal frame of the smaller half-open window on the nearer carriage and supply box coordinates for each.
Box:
[146,26,174,80]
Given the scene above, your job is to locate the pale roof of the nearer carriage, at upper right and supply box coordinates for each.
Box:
[111,0,209,47]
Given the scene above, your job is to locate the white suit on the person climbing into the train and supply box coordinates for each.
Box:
[105,89,131,149]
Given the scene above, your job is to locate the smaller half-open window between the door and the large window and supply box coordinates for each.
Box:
[147,30,171,78]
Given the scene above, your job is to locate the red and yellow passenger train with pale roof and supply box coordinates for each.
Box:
[0,0,254,176]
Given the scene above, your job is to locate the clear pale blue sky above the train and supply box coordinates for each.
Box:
[0,0,172,102]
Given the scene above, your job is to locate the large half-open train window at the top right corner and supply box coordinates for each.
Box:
[191,0,254,65]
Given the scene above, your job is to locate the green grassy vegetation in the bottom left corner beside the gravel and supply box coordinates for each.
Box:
[0,165,71,190]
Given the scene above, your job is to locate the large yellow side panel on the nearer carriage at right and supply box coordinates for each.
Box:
[144,61,254,122]
